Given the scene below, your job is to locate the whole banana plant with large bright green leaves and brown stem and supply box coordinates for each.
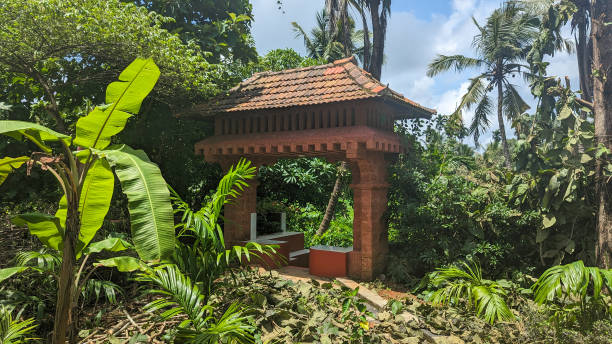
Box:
[0,58,175,344]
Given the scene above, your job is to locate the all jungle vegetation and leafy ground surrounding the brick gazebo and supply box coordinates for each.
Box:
[0,0,612,343]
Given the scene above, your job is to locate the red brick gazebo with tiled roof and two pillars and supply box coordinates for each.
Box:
[195,58,435,280]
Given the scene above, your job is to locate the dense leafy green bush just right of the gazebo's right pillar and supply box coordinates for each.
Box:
[387,118,540,280]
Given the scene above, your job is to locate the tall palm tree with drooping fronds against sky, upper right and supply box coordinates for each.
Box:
[427,3,539,168]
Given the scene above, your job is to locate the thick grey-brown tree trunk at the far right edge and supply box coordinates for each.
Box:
[591,0,612,269]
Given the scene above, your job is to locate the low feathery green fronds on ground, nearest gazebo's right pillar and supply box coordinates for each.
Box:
[430,262,514,324]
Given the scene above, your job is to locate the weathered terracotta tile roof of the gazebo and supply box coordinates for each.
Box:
[194,57,435,117]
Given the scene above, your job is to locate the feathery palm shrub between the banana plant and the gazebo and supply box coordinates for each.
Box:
[133,160,276,343]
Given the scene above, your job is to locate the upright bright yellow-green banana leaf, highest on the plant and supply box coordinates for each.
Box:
[74,59,160,149]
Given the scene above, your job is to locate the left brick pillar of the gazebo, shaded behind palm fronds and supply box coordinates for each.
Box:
[221,164,259,247]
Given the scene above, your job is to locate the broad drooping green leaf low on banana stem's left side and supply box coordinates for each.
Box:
[11,213,64,251]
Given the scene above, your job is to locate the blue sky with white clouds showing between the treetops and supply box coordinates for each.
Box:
[252,0,578,144]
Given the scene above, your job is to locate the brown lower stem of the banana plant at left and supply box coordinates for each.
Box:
[53,203,80,344]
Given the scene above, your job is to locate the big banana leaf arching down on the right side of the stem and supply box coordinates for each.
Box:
[97,145,174,260]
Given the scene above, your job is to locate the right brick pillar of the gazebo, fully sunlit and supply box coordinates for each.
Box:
[349,152,389,280]
